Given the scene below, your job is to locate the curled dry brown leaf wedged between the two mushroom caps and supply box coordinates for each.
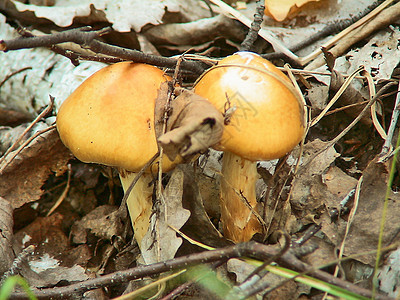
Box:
[155,85,224,160]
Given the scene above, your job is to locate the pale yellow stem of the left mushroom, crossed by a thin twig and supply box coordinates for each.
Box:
[119,171,153,248]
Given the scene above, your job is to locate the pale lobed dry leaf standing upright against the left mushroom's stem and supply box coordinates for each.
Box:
[140,168,190,264]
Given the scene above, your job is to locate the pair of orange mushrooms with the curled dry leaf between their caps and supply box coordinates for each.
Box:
[57,52,304,246]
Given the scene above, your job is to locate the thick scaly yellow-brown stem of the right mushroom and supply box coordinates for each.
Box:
[220,152,262,243]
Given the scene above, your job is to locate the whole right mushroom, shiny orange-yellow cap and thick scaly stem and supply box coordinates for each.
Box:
[195,52,305,242]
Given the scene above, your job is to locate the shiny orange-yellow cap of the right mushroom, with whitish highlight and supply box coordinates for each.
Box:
[195,52,304,161]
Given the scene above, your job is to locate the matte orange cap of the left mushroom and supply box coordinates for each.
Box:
[57,62,174,172]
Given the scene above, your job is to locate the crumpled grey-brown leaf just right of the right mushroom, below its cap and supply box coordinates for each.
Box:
[291,140,357,251]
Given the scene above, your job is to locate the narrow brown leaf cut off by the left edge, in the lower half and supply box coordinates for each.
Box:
[0,197,14,274]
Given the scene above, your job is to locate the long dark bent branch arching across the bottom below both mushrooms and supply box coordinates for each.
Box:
[10,242,390,299]
